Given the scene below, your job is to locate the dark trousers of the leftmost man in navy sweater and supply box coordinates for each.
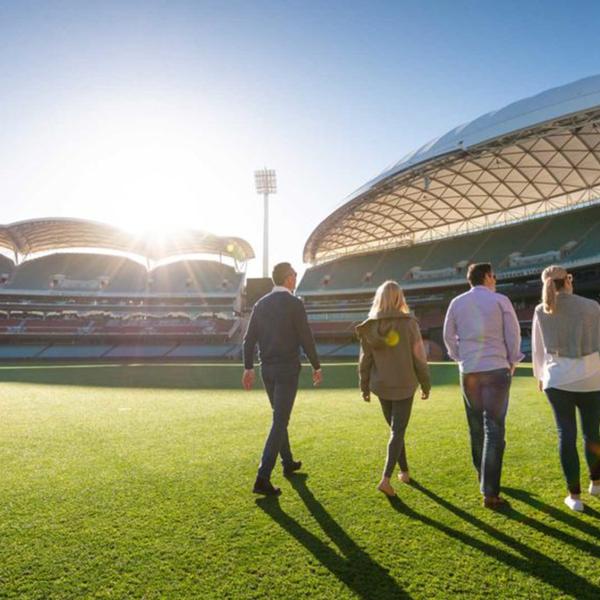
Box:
[258,365,300,479]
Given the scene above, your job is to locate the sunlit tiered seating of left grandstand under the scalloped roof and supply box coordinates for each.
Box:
[0,247,244,360]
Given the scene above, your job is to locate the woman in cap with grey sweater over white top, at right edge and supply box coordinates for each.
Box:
[532,265,600,512]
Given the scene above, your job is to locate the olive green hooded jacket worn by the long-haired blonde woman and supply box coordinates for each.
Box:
[356,311,431,400]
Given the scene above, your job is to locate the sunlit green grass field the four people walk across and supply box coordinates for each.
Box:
[0,366,600,599]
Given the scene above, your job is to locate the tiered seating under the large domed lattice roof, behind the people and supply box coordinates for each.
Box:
[298,205,600,360]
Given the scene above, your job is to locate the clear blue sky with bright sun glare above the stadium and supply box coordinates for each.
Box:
[0,0,600,275]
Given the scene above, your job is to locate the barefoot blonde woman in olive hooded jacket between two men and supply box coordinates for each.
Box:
[356,281,431,496]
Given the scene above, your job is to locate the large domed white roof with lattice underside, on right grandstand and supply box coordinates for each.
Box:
[304,76,600,263]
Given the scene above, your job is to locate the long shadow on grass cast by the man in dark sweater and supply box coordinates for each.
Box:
[256,474,411,600]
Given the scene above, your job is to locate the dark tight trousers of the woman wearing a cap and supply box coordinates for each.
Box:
[545,388,600,494]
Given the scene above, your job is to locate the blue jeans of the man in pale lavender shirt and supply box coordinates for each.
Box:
[460,369,512,496]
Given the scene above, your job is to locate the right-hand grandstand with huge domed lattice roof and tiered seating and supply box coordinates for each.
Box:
[298,76,600,359]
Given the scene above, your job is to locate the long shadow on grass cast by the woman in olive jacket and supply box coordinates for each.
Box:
[389,479,600,599]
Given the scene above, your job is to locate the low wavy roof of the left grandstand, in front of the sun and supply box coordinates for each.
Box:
[0,218,254,261]
